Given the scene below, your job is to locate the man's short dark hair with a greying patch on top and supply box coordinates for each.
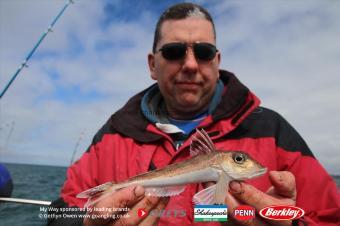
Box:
[152,2,216,53]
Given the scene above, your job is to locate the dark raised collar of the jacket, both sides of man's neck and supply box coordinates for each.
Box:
[109,70,259,143]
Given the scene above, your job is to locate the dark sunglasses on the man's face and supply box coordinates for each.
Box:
[157,42,218,61]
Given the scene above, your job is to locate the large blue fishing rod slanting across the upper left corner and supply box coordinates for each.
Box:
[0,0,74,99]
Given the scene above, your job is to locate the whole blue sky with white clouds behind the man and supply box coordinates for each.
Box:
[0,0,340,175]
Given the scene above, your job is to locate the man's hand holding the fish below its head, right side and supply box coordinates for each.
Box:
[226,171,296,226]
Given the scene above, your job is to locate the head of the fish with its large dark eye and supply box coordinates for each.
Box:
[222,151,267,180]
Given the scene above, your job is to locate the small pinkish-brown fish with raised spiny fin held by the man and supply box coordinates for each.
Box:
[77,129,267,207]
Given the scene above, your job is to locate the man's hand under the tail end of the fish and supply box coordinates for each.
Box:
[84,186,169,226]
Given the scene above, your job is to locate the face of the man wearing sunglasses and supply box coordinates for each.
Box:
[148,17,220,119]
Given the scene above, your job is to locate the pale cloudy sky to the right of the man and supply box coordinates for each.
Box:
[207,1,340,173]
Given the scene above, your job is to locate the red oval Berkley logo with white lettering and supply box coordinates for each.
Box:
[259,205,305,220]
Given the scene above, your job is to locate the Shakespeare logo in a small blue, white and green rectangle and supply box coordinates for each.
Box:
[194,205,228,222]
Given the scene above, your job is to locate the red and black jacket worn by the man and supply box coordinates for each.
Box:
[49,71,340,225]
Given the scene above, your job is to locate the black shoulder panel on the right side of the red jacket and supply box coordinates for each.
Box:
[224,107,314,157]
